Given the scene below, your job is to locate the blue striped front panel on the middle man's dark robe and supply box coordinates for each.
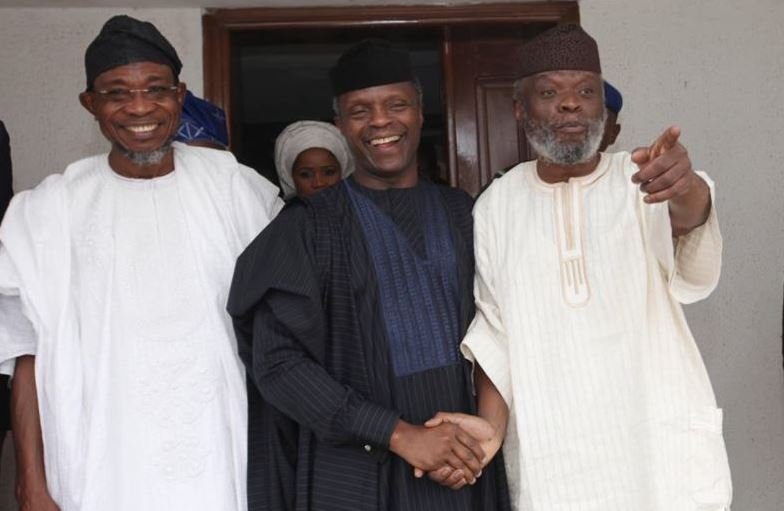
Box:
[346,183,460,377]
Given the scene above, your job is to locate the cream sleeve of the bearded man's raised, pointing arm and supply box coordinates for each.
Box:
[640,171,723,304]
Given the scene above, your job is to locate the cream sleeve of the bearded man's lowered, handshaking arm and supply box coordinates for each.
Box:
[460,202,512,408]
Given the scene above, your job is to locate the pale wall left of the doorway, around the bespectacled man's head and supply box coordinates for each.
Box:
[0,8,202,190]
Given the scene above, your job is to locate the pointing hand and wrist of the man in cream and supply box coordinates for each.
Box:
[632,126,711,236]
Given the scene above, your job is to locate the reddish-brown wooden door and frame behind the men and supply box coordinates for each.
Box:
[203,5,579,196]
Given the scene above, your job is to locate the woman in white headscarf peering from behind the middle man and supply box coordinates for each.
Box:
[275,121,354,200]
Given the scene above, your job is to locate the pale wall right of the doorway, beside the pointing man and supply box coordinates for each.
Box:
[580,0,784,511]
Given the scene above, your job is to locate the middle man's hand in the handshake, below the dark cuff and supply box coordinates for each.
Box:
[389,420,485,484]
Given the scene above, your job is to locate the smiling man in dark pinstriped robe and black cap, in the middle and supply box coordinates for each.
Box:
[228,40,509,511]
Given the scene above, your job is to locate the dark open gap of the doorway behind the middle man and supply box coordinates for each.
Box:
[231,29,449,188]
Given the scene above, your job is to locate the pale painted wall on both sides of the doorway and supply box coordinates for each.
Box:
[0,0,784,511]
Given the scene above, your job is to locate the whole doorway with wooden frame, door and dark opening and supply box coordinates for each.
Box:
[203,1,579,195]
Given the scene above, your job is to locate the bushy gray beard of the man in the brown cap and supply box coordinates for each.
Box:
[525,111,607,165]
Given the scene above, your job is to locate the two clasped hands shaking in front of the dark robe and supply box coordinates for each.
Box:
[390,412,503,490]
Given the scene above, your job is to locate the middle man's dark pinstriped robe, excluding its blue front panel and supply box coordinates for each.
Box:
[229,181,508,511]
